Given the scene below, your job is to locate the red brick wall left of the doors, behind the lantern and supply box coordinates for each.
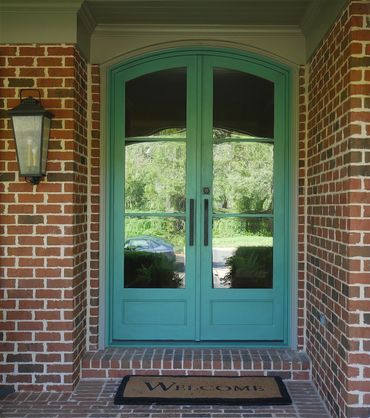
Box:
[0,45,88,390]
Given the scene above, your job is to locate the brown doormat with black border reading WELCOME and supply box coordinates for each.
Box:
[114,376,292,405]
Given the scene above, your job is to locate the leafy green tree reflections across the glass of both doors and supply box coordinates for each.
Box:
[125,129,273,245]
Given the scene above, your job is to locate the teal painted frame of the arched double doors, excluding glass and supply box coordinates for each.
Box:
[108,48,289,343]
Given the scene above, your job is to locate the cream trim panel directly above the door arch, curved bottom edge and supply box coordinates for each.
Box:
[91,25,305,65]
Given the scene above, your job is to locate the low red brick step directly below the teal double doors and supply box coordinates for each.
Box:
[81,348,310,380]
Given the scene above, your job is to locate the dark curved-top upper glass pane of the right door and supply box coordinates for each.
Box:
[213,68,274,140]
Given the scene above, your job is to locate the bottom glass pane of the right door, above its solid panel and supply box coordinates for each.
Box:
[212,218,273,289]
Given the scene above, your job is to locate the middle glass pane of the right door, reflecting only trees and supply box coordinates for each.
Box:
[213,142,274,213]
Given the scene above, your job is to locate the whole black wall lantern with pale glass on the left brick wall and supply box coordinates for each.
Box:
[8,90,54,184]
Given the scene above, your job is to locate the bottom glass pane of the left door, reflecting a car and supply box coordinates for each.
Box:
[124,217,185,288]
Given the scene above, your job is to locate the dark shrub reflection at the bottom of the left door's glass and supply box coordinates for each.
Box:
[125,251,181,288]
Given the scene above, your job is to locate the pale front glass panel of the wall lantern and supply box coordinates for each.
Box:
[13,115,43,176]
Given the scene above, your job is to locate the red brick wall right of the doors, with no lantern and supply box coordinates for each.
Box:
[302,1,370,418]
